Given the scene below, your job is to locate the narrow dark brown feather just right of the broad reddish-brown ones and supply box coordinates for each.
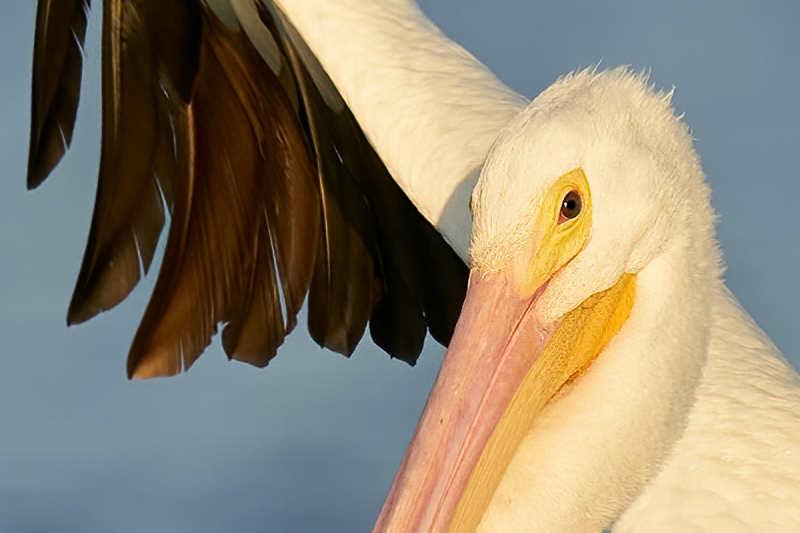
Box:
[268,14,382,355]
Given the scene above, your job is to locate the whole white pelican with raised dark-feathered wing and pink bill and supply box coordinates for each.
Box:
[28,0,800,532]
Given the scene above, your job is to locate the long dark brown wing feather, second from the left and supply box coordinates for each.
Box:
[67,0,201,324]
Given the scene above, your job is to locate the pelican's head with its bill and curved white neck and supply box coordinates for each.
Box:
[377,69,719,531]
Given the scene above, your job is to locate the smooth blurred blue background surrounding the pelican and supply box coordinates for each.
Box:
[0,0,800,533]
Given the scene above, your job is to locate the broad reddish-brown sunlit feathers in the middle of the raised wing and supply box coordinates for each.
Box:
[128,14,319,377]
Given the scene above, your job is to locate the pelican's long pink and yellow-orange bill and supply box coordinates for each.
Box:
[374,270,636,533]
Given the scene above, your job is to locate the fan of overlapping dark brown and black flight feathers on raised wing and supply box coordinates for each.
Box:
[31,0,467,377]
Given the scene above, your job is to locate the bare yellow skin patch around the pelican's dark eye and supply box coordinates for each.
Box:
[515,167,592,295]
